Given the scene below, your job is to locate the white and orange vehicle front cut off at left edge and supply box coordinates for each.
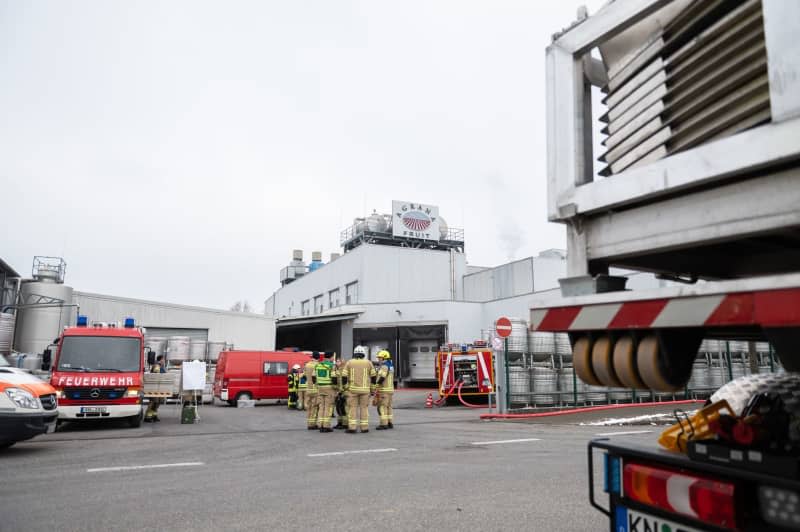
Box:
[0,364,58,449]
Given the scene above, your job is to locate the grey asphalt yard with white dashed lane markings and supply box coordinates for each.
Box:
[0,391,661,532]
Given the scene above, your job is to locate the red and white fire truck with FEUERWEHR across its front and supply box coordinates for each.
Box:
[50,316,145,427]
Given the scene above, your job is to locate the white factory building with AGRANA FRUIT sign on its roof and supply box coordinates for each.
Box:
[264,201,657,382]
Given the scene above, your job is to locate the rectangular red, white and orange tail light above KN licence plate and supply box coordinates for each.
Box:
[623,463,736,530]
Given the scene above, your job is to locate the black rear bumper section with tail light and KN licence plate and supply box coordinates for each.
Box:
[588,439,800,532]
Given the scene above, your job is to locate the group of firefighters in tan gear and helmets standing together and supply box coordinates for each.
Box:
[288,345,394,434]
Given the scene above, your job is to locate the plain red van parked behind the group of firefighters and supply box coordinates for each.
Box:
[214,351,311,405]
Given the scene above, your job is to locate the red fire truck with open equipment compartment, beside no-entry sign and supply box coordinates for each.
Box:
[436,344,494,398]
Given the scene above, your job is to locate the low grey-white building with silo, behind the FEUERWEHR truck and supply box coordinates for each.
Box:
[0,257,275,369]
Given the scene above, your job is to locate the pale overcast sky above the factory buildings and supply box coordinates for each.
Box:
[0,0,601,311]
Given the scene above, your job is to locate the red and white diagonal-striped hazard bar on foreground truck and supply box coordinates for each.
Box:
[531,288,800,332]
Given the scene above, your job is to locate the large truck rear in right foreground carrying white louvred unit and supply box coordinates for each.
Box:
[530,0,800,532]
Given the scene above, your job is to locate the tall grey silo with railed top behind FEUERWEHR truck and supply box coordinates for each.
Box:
[14,257,72,353]
